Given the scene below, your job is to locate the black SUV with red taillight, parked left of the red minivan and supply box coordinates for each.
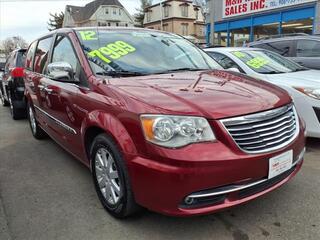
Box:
[0,49,26,119]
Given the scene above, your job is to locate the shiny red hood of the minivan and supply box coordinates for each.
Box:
[108,70,291,119]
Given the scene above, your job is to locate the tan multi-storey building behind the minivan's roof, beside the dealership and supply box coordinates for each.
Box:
[143,0,205,43]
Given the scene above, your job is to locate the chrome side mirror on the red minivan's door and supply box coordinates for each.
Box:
[48,62,75,82]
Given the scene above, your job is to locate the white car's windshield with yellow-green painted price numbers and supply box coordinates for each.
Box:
[232,50,307,74]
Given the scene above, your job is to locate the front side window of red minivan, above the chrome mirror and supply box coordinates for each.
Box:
[51,36,78,72]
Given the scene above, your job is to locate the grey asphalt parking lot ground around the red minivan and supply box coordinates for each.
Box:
[0,107,320,240]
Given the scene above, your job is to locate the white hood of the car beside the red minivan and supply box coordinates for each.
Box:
[264,70,320,88]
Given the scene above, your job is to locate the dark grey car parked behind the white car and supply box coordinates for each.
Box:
[248,34,320,70]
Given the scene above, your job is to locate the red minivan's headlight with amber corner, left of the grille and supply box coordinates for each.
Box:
[140,114,216,148]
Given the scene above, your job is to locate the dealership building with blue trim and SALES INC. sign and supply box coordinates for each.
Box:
[206,0,320,46]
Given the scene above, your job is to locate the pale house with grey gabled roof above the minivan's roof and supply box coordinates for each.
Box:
[63,0,134,27]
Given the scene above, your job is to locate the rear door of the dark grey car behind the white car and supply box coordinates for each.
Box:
[292,39,320,70]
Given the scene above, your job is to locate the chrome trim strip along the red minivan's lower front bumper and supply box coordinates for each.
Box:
[187,148,306,198]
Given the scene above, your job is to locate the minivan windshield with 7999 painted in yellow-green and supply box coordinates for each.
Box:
[77,29,221,75]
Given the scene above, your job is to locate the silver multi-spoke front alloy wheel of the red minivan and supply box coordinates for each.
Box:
[95,148,122,206]
